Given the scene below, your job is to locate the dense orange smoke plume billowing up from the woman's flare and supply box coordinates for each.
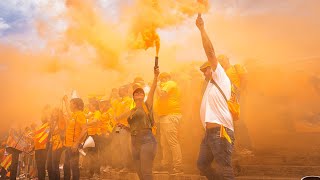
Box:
[128,0,209,55]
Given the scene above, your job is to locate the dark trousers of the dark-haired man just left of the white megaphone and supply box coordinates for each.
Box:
[63,148,80,180]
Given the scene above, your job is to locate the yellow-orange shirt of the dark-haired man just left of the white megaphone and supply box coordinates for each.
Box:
[65,111,86,147]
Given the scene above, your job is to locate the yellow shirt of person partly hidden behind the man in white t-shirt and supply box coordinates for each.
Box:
[226,64,247,88]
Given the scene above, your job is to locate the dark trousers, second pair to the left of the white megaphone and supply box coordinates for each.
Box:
[47,148,63,180]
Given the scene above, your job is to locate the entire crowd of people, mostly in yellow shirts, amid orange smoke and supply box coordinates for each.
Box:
[0,16,247,180]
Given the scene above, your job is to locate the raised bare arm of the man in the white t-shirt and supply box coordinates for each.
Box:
[196,16,218,70]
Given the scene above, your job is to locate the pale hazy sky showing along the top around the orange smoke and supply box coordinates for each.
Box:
[0,0,320,55]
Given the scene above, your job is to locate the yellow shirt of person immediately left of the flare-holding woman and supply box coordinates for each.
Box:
[116,96,133,126]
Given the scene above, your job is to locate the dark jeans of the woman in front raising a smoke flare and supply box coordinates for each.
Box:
[131,130,157,180]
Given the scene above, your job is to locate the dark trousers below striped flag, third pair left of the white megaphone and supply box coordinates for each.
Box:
[35,149,47,180]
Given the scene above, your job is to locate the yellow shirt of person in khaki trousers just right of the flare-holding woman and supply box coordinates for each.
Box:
[157,81,181,116]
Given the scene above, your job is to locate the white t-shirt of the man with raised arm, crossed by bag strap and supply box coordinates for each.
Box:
[200,63,234,131]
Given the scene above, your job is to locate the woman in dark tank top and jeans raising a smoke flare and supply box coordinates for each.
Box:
[128,68,159,180]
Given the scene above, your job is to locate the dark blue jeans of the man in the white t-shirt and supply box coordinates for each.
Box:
[197,127,234,180]
